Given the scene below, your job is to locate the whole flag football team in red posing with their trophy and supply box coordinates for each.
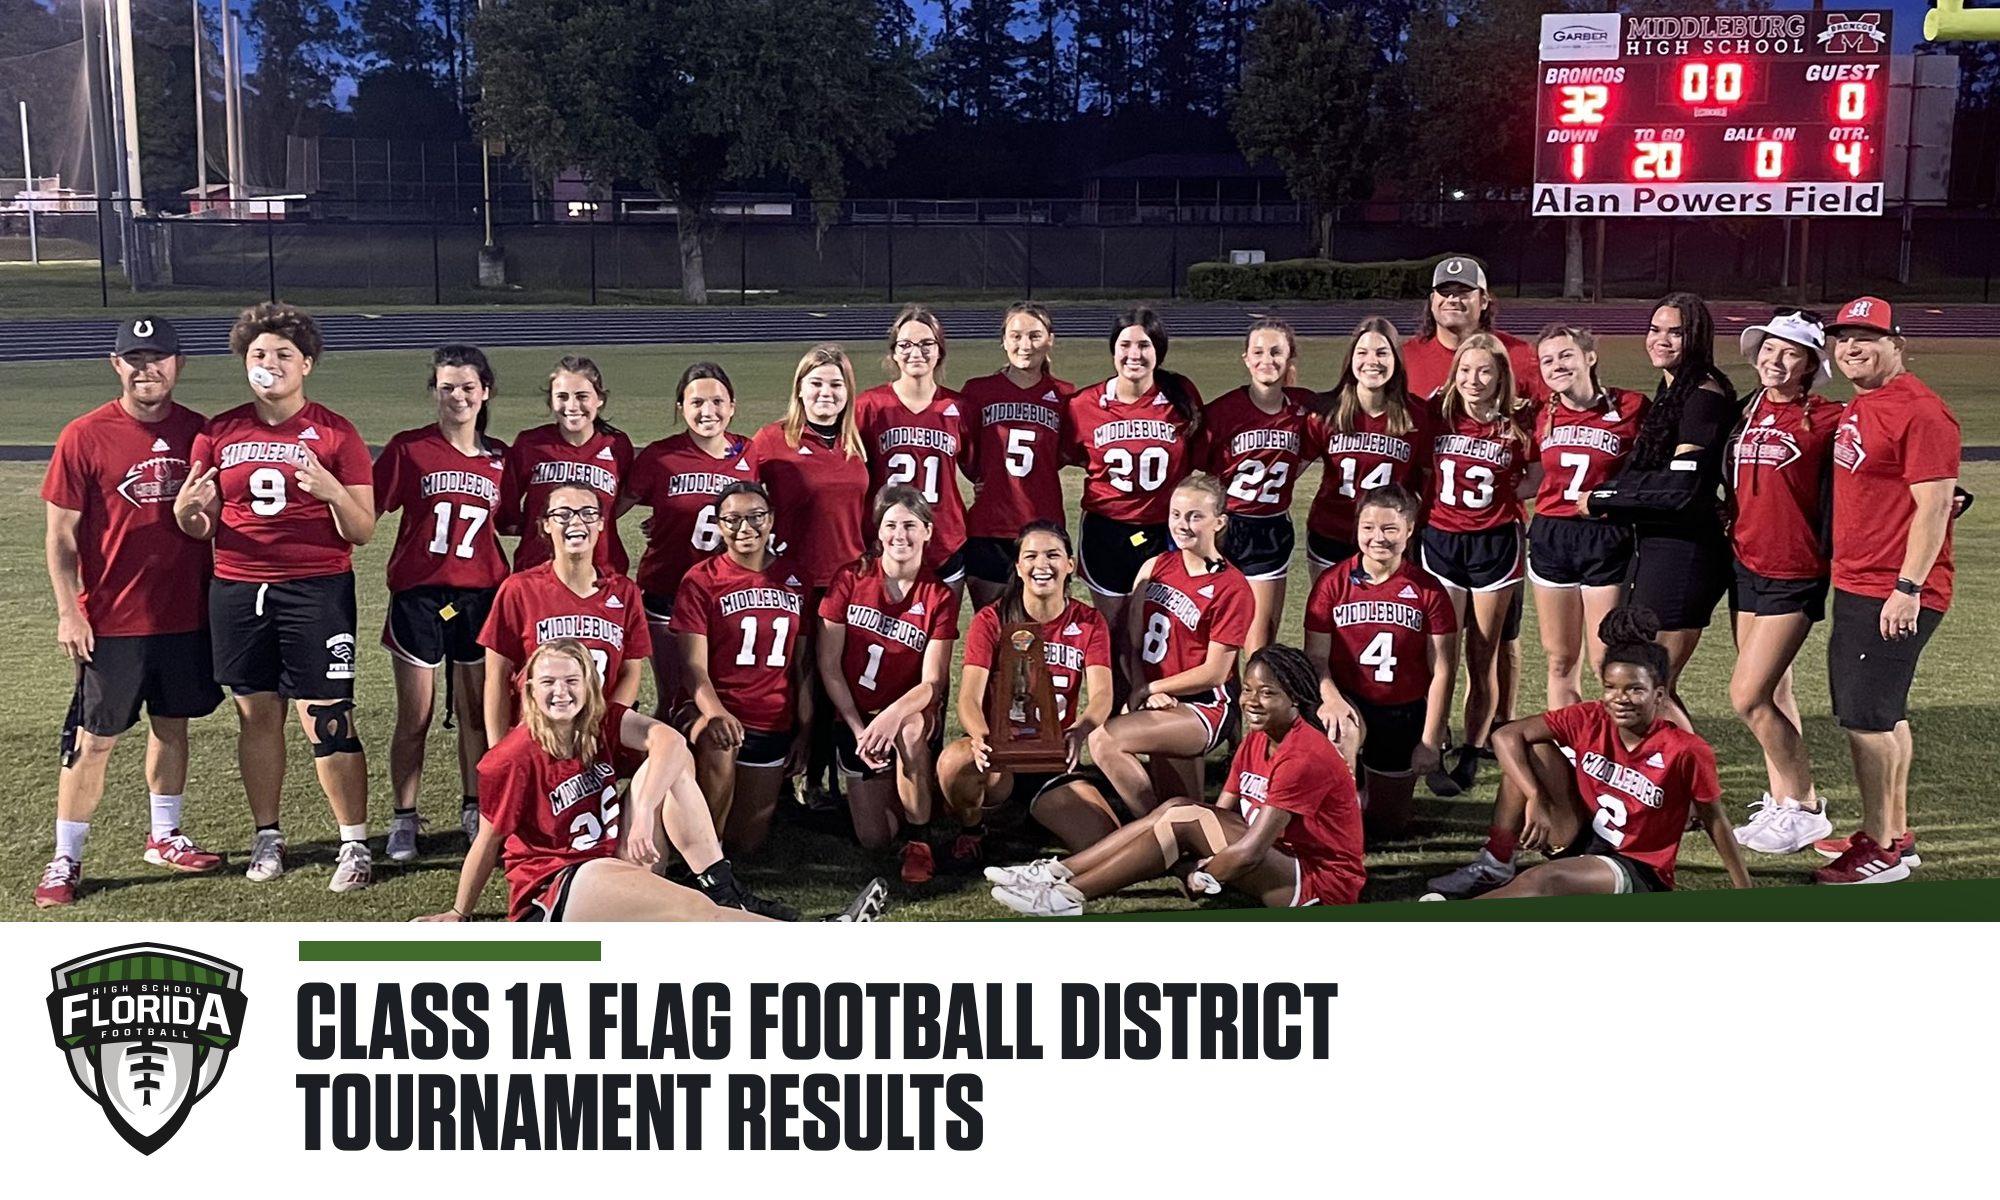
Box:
[39,256,1970,922]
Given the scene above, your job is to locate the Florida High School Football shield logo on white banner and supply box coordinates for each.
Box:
[48,944,244,1154]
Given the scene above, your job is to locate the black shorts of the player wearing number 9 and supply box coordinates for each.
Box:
[208,572,358,700]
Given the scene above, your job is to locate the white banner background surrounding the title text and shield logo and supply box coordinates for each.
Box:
[0,922,2000,1198]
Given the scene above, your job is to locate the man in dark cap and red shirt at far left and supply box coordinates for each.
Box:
[34,316,222,908]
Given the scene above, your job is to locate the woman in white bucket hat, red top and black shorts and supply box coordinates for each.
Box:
[1724,310,1840,854]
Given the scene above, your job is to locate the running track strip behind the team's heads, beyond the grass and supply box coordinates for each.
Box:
[0,300,2000,362]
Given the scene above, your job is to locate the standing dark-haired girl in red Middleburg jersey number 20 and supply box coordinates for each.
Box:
[1064,306,1202,710]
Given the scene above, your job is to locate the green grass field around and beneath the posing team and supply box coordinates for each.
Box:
[0,338,2000,920]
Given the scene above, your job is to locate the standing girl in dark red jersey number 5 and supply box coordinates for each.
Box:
[960,300,1076,608]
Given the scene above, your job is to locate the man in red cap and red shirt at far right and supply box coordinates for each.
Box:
[1816,296,1958,884]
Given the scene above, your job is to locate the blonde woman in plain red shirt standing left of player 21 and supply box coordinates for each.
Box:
[750,344,868,812]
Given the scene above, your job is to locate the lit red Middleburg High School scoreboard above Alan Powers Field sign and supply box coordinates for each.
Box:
[1534,10,1890,216]
